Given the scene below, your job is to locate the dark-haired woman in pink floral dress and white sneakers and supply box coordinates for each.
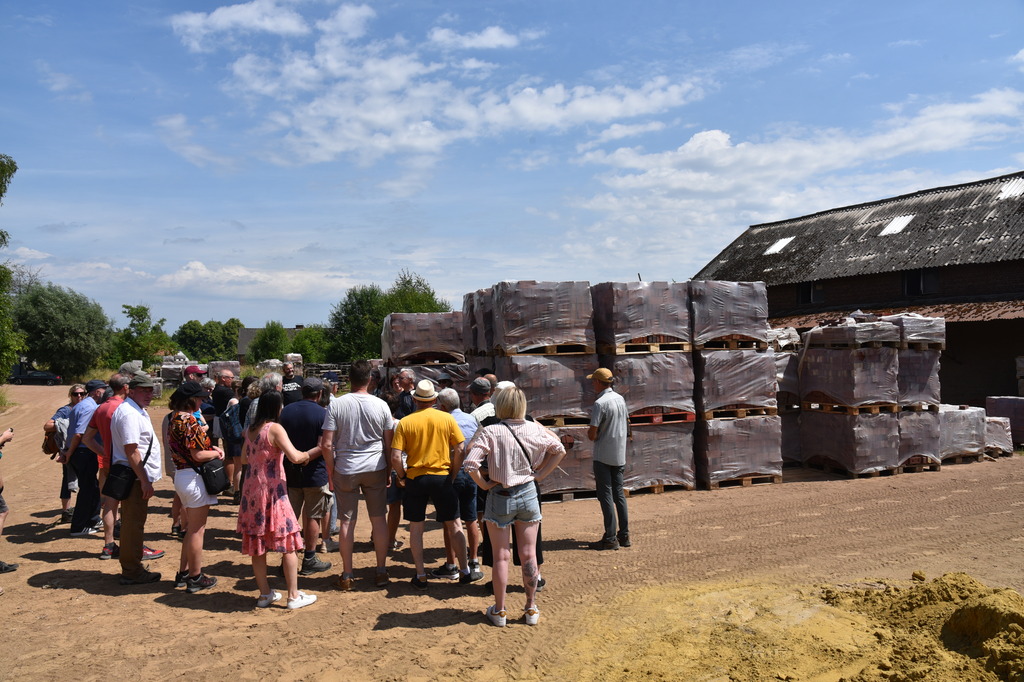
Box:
[238,391,319,609]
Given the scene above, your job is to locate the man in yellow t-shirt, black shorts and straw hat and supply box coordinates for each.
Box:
[391,379,483,590]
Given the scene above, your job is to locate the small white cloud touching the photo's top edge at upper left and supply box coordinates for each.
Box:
[171,0,309,52]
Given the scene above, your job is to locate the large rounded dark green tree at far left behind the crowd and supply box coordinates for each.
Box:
[13,283,113,378]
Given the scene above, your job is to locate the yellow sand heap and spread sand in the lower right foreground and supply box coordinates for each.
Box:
[557,573,1024,682]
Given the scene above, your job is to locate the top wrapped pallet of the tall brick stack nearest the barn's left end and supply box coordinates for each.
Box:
[690,280,769,344]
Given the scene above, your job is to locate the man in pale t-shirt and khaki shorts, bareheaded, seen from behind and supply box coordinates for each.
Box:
[321,360,394,592]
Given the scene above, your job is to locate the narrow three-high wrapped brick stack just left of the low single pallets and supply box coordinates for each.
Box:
[882,314,946,466]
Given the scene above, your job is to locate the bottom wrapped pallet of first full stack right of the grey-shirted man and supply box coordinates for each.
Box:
[693,417,782,485]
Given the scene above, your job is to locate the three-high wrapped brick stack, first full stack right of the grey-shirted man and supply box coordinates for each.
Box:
[689,282,782,488]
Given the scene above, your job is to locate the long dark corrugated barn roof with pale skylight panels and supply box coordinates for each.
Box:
[693,172,1024,286]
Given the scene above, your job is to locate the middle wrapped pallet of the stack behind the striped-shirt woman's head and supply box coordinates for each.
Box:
[494,354,598,419]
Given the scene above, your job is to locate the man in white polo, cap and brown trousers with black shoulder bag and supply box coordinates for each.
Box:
[111,374,164,585]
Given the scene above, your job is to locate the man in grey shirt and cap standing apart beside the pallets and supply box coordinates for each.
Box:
[587,368,631,550]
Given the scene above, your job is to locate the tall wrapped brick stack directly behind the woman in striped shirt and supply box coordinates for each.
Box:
[471,281,598,494]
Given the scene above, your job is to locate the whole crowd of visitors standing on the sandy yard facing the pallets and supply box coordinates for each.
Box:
[25,360,631,627]
